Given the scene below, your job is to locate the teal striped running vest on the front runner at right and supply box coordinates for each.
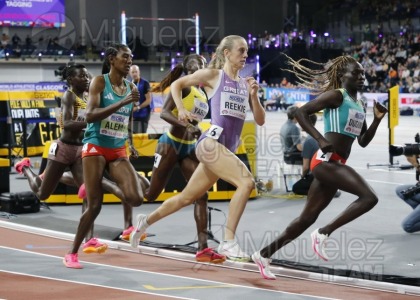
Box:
[324,89,366,138]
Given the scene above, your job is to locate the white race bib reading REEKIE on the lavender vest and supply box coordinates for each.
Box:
[220,92,248,120]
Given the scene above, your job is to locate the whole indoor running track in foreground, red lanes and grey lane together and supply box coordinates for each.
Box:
[0,226,418,300]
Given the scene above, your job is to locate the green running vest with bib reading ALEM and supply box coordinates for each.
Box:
[83,74,133,148]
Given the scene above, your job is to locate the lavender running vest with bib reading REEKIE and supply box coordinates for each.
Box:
[199,70,249,152]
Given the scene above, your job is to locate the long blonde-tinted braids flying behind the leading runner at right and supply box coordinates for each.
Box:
[285,55,357,94]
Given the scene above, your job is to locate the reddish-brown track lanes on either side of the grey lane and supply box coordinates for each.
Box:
[0,227,418,300]
